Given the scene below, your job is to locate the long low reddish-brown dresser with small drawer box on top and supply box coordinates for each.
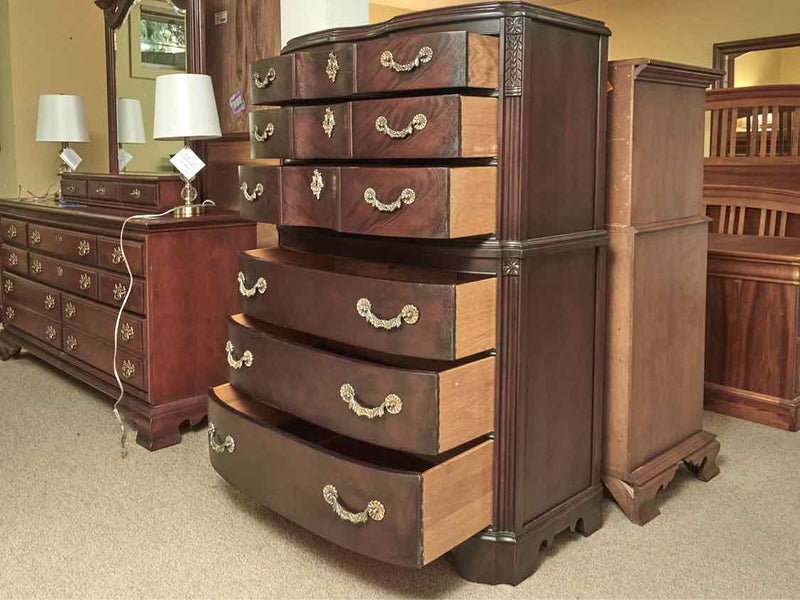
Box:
[0,173,256,450]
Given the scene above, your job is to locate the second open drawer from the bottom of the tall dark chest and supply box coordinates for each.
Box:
[227,315,495,455]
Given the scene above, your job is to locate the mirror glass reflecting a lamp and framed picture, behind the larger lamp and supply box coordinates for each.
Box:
[114,0,187,173]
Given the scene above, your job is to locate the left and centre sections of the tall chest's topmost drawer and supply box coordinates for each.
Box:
[250,44,354,105]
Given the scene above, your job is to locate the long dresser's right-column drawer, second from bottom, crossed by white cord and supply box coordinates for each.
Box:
[61,294,147,354]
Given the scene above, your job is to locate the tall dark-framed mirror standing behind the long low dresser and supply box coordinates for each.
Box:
[95,0,198,174]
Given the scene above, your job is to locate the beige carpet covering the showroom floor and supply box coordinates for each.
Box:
[0,356,800,600]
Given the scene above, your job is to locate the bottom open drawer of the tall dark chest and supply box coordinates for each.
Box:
[208,385,494,567]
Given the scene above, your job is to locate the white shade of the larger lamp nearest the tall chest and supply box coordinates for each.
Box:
[153,73,222,140]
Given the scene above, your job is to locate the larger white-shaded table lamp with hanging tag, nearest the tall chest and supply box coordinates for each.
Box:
[153,73,222,217]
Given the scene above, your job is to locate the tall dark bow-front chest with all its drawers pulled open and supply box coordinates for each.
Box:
[209,2,609,584]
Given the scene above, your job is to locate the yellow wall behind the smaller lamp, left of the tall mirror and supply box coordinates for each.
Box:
[5,0,108,196]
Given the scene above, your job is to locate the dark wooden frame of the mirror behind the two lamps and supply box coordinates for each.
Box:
[94,0,205,175]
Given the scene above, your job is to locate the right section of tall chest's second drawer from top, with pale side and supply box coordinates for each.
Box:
[352,95,497,158]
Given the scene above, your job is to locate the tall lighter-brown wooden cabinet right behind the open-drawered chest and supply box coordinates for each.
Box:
[603,59,719,525]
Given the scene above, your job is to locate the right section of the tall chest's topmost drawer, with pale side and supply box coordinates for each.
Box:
[356,31,498,93]
